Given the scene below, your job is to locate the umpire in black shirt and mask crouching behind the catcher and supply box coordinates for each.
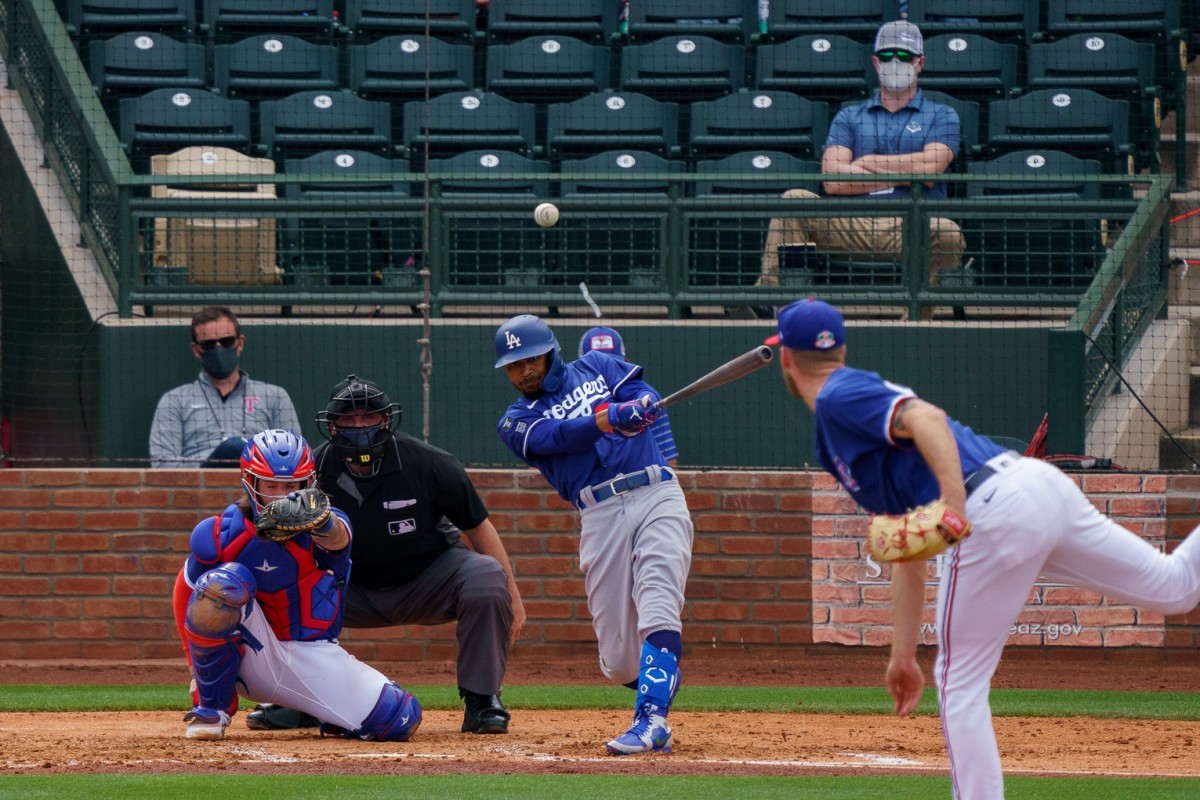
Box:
[246,374,526,733]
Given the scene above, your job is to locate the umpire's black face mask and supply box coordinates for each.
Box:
[317,374,403,477]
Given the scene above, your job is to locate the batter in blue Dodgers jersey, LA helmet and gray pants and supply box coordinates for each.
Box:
[496,314,694,756]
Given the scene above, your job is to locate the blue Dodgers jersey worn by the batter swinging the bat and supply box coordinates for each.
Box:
[498,350,667,503]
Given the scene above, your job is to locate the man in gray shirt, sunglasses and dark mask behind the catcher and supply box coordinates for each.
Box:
[150,306,300,468]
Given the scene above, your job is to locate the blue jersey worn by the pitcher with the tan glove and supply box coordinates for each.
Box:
[814,367,1004,513]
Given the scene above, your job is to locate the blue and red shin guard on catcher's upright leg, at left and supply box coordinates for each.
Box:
[184,563,256,714]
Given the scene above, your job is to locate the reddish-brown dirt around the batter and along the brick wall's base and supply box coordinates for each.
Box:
[0,648,1200,776]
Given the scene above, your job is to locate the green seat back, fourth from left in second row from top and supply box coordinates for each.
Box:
[485,34,611,104]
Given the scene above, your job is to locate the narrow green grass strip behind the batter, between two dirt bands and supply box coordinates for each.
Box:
[0,685,1200,721]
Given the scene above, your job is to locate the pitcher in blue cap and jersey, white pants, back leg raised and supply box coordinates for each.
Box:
[767,300,1200,800]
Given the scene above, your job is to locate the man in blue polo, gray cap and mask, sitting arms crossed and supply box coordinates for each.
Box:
[758,19,965,319]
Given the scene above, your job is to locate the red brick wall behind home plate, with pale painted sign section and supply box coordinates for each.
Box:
[0,469,1200,661]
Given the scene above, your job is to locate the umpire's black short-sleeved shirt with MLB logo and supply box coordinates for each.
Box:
[314,431,487,589]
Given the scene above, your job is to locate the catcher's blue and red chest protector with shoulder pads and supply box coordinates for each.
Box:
[184,504,353,642]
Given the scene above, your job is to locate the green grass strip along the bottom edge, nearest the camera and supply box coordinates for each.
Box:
[0,775,1200,800]
